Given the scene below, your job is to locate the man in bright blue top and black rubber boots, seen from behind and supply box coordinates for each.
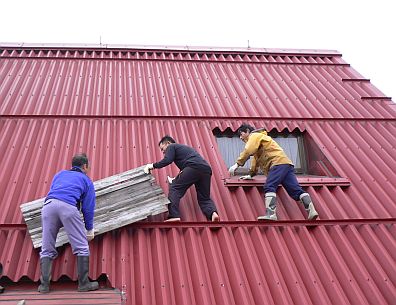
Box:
[38,153,99,293]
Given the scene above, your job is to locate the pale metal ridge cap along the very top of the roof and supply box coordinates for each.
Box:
[0,42,342,56]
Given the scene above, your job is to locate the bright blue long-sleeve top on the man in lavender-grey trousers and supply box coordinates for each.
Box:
[45,167,96,230]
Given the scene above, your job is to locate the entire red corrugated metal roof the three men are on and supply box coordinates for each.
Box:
[0,45,396,305]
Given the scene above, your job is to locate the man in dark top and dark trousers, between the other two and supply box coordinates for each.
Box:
[144,136,220,221]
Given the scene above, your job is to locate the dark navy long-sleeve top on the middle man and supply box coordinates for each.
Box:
[153,143,212,174]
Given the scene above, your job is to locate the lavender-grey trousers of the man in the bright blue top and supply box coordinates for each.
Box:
[40,199,89,259]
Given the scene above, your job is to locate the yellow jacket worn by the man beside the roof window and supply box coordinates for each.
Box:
[236,130,293,176]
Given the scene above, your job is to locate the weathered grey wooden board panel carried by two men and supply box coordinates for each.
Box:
[21,166,169,248]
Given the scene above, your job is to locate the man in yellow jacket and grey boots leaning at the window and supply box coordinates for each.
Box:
[229,124,319,220]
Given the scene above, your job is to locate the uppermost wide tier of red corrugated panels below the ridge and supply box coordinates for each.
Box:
[0,57,392,118]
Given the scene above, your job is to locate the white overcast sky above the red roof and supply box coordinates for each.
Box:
[0,0,396,102]
